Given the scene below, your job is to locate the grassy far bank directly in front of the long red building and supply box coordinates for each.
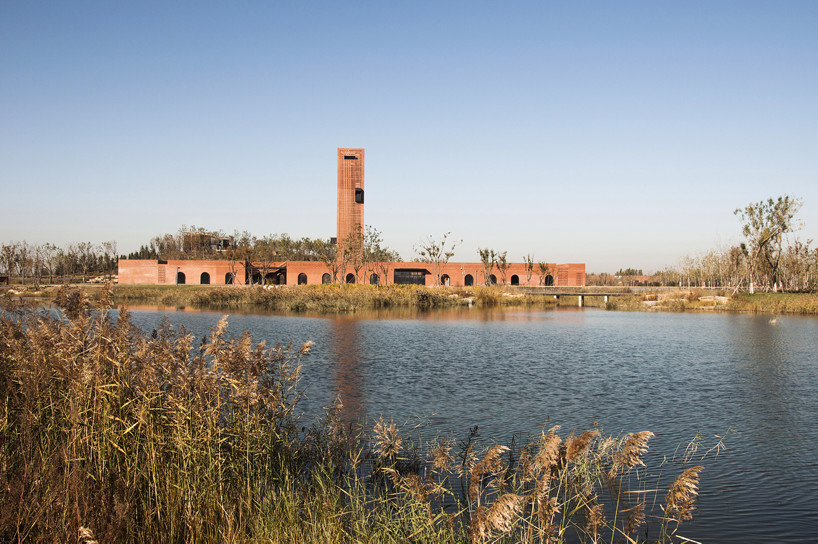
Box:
[108,284,553,312]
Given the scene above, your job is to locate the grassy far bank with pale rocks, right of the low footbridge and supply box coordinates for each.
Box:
[604,289,818,315]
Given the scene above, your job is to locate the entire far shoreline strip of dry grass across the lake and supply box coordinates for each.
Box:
[0,284,818,316]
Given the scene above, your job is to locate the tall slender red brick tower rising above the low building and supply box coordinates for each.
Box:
[337,147,364,251]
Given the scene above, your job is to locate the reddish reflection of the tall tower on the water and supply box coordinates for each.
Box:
[330,319,366,425]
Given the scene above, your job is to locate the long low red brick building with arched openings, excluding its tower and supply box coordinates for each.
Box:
[118,259,585,287]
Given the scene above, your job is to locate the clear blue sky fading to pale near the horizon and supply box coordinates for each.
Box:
[0,0,818,272]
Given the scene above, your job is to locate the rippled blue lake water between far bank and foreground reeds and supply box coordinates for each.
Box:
[127,309,818,543]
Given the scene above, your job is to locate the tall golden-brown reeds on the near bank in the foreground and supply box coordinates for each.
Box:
[0,288,702,544]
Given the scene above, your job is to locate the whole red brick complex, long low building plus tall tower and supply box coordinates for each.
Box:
[119,148,585,287]
